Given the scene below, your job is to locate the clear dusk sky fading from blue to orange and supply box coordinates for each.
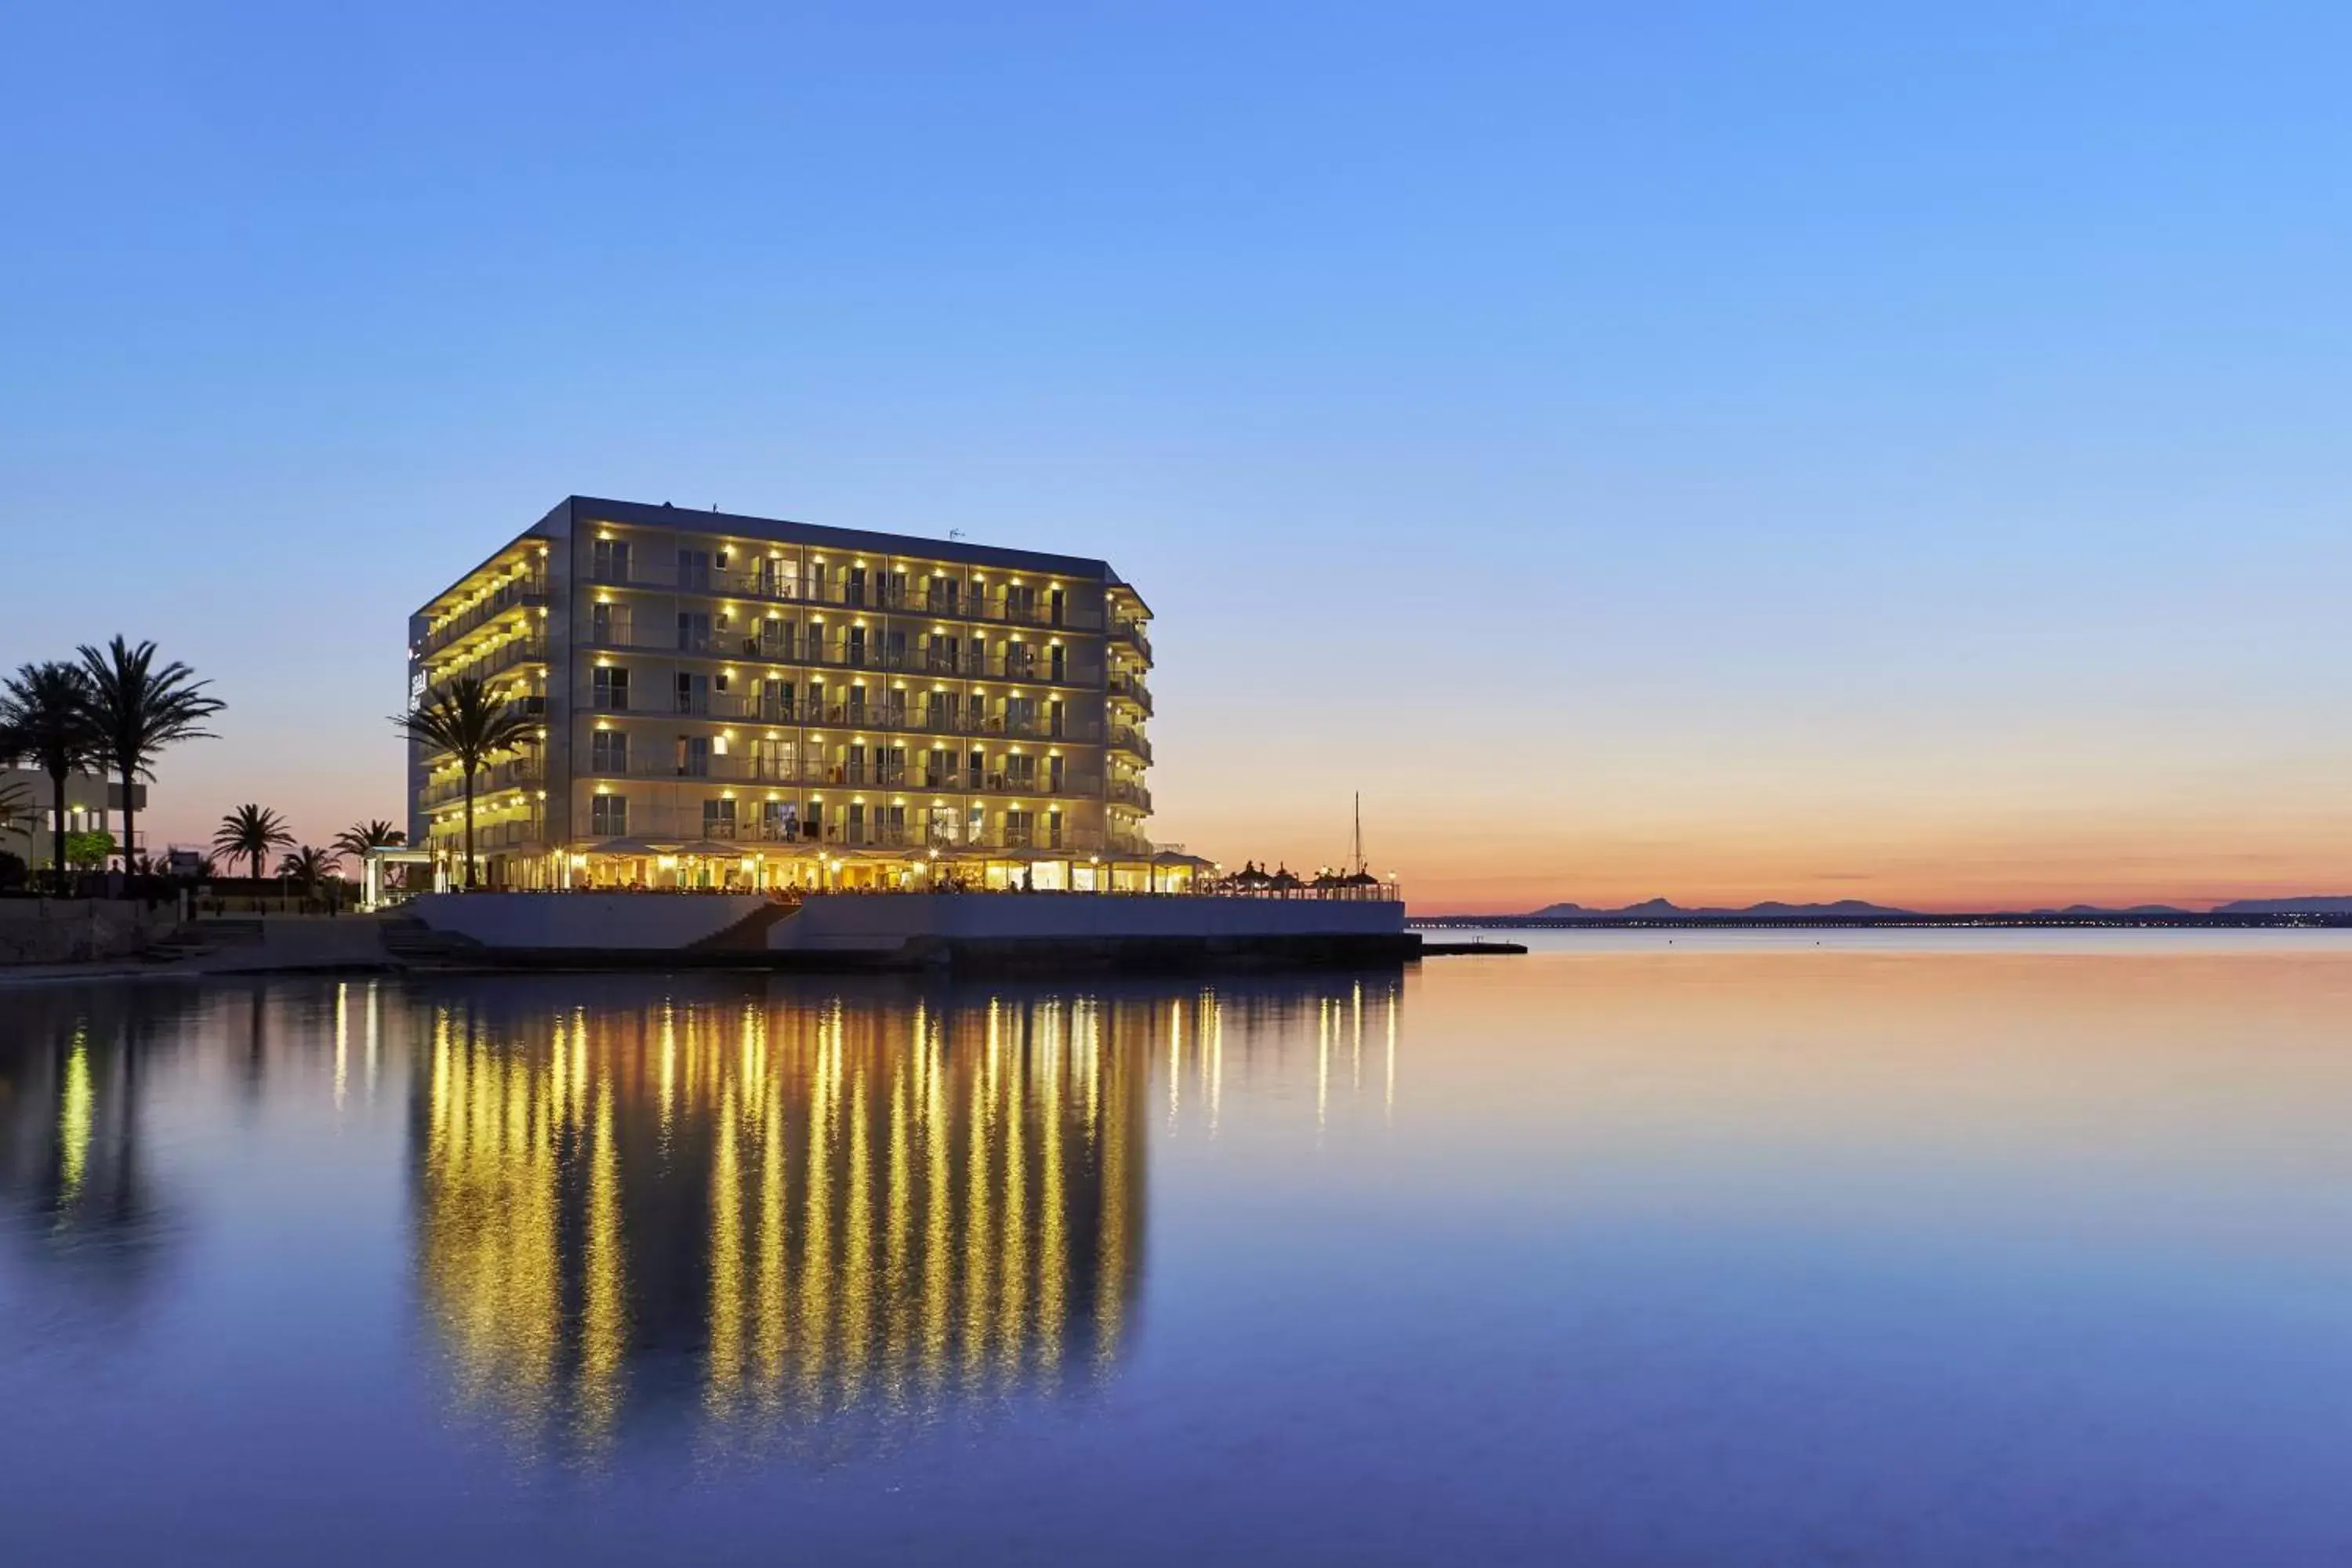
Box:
[0,0,2352,909]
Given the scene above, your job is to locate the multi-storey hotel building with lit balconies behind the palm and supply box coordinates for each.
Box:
[409,496,1167,891]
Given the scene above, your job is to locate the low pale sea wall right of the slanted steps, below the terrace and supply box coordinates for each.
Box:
[767,893,1404,952]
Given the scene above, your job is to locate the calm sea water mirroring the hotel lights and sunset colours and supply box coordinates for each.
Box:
[0,933,2352,1568]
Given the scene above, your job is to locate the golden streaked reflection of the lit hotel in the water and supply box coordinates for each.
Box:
[414,992,1152,1436]
